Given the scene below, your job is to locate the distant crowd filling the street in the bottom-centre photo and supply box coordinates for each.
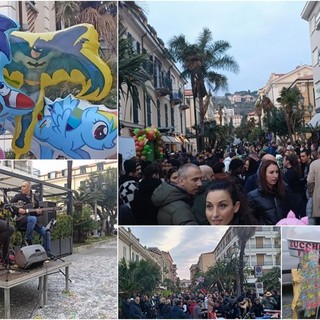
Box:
[119,290,281,319]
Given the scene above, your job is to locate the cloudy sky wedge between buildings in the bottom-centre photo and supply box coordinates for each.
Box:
[124,226,228,279]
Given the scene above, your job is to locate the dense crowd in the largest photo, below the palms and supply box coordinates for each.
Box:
[119,142,320,225]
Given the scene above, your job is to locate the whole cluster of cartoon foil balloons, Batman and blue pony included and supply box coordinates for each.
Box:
[0,16,117,159]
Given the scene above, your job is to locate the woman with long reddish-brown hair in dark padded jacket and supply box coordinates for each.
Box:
[248,160,289,225]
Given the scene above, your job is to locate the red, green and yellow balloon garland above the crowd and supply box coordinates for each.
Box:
[133,128,164,161]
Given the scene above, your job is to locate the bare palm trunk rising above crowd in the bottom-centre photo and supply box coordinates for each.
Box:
[235,227,256,297]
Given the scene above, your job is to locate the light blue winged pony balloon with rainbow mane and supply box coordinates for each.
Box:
[32,95,118,159]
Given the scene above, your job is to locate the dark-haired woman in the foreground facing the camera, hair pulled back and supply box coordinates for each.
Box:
[206,178,260,225]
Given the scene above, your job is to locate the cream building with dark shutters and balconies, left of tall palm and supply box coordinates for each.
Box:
[119,8,189,151]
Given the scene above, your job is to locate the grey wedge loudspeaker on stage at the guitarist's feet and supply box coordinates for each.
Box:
[15,244,48,269]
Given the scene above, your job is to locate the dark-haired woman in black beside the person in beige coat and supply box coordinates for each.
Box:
[283,153,306,218]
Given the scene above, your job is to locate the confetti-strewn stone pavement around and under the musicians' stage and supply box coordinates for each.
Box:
[0,237,118,319]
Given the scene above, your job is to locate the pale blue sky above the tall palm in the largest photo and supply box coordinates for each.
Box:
[138,1,311,94]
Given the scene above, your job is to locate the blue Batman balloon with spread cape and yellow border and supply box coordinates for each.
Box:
[4,20,112,158]
